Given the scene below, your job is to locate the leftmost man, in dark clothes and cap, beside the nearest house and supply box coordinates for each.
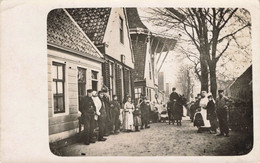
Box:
[81,89,96,145]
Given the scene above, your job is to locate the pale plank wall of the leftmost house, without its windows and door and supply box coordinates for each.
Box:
[48,48,103,142]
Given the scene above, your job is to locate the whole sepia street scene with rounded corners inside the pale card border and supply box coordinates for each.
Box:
[45,7,252,157]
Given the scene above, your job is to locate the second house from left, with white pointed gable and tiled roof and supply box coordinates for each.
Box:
[67,8,134,102]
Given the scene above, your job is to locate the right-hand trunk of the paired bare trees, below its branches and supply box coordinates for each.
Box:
[209,63,217,99]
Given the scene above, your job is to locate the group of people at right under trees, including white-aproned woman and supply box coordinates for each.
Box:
[190,90,229,137]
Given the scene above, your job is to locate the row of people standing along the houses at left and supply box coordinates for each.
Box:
[79,89,151,145]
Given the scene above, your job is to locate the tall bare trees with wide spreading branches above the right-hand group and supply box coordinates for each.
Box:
[147,8,251,97]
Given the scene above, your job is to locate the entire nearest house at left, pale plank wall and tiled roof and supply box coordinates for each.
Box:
[47,9,104,143]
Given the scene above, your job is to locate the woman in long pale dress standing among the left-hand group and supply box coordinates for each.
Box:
[123,97,134,131]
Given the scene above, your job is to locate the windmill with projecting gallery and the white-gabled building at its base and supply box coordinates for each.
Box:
[126,8,177,102]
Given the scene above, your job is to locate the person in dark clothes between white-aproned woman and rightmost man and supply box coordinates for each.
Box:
[206,95,217,134]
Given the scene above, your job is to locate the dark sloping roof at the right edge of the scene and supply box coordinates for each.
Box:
[230,65,252,89]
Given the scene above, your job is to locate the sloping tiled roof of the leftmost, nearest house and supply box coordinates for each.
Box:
[47,9,102,58]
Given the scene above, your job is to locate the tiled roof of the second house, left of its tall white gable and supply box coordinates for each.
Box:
[66,8,111,45]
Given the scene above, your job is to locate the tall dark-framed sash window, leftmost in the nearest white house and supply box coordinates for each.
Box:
[52,62,65,114]
